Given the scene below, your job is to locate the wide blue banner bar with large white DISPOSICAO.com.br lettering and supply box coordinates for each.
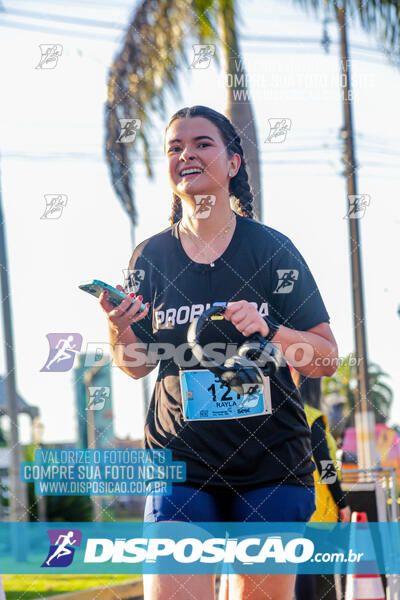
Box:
[0,522,400,574]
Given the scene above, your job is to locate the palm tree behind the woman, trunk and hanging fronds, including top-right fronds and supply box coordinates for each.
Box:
[105,0,400,230]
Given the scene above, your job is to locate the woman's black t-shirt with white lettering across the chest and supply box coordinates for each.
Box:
[125,215,329,490]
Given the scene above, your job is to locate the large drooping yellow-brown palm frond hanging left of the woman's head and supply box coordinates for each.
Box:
[105,0,218,224]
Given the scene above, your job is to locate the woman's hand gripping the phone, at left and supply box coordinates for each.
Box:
[99,285,150,334]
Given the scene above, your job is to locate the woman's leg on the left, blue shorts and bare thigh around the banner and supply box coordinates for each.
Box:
[143,486,219,600]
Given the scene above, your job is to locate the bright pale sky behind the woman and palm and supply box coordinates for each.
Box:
[0,0,400,444]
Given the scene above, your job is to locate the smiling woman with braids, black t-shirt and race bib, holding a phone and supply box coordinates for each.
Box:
[100,106,337,600]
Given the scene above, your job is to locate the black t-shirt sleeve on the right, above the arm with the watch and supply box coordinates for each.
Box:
[269,236,330,331]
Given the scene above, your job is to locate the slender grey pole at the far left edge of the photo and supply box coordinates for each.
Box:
[0,157,28,522]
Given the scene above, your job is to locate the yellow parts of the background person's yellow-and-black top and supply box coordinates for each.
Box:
[304,403,341,523]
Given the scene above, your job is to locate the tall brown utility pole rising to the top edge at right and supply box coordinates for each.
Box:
[337,0,378,469]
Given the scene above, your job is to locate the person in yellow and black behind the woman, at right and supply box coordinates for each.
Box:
[290,367,351,600]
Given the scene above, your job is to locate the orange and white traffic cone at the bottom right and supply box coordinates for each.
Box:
[345,512,385,600]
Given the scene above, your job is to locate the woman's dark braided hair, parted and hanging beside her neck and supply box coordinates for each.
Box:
[165,106,254,225]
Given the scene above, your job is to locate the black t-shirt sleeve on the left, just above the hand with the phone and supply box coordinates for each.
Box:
[122,243,156,344]
